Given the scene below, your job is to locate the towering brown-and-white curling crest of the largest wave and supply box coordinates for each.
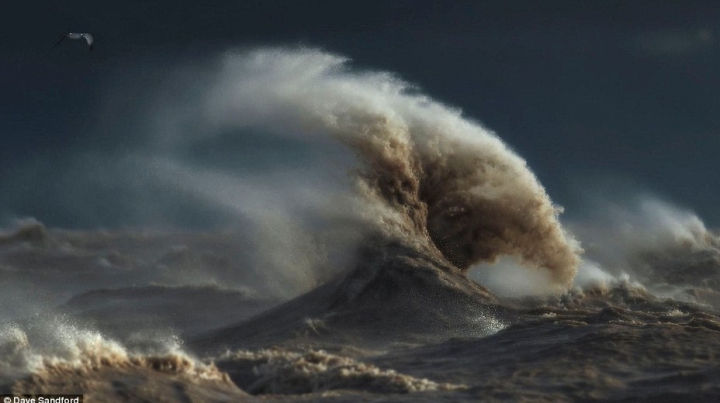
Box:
[200,49,580,286]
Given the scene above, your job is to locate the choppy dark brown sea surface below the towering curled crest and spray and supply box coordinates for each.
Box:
[0,225,720,402]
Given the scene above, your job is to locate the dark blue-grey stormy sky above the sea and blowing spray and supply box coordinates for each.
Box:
[0,0,720,227]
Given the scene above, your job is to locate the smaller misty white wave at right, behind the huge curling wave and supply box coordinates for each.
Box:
[569,196,720,292]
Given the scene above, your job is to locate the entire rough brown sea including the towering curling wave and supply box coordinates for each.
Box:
[0,49,720,402]
